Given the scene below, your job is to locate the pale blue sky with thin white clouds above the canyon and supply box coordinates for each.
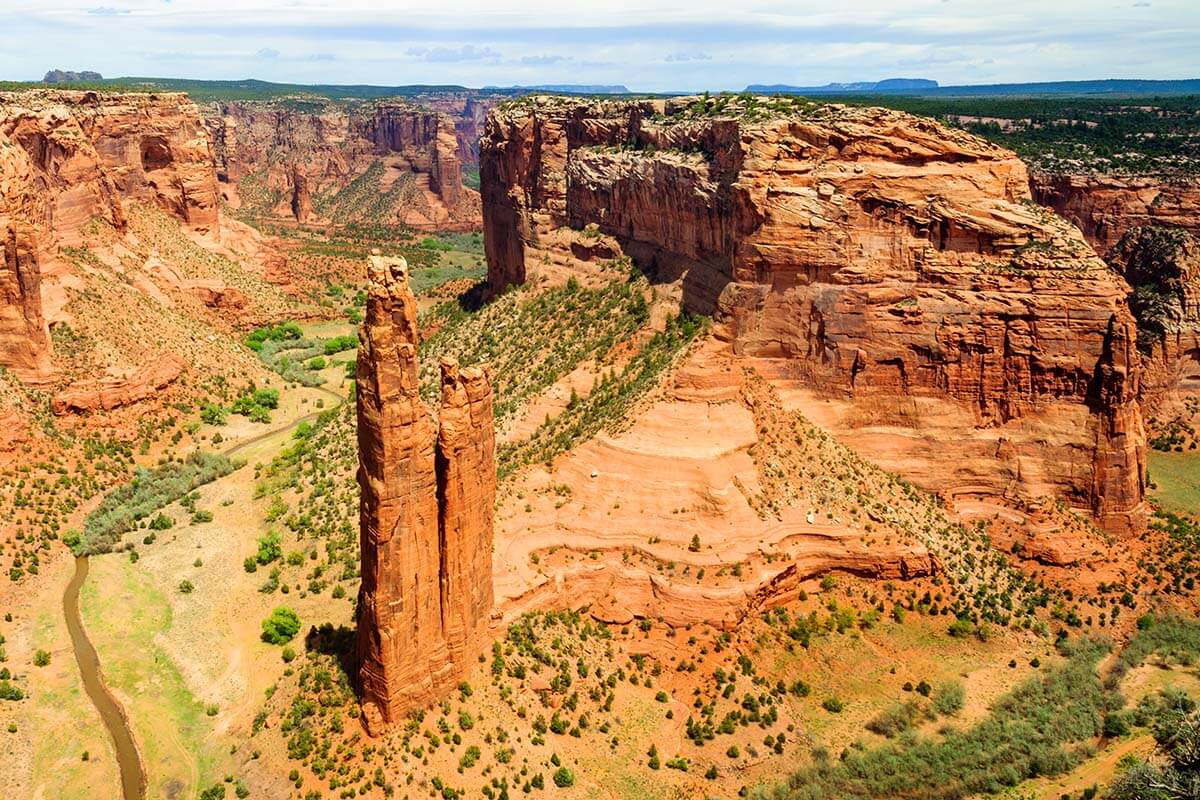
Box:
[0,0,1200,91]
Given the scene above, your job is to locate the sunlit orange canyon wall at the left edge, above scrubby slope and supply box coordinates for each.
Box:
[0,90,218,379]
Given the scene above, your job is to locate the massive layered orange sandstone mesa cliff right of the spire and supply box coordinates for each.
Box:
[480,98,1145,531]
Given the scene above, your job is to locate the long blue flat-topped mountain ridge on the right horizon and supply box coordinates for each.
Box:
[746,78,1200,97]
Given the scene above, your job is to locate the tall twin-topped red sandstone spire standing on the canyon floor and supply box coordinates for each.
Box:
[358,257,496,733]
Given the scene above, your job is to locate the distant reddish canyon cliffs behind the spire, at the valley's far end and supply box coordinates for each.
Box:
[208,102,479,224]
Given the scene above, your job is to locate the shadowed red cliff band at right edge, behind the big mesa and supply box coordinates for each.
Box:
[1030,173,1200,255]
